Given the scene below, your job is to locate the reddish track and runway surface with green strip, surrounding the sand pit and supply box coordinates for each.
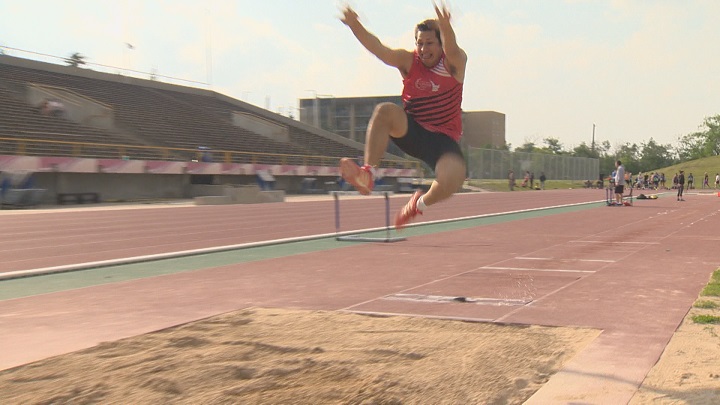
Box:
[0,190,720,404]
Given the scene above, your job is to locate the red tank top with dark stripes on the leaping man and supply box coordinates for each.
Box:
[402,51,463,141]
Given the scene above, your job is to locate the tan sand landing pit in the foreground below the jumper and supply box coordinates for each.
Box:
[0,308,600,404]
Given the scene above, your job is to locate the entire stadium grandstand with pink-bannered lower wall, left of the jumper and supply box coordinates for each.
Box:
[0,55,420,203]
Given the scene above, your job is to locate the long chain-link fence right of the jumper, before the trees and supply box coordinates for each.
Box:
[467,148,601,181]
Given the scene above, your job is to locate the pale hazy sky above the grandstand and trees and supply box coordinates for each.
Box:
[0,0,720,150]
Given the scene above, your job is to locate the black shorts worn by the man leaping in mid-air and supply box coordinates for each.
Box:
[390,115,465,170]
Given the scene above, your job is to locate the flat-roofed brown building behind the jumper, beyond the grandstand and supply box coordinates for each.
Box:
[299,96,505,148]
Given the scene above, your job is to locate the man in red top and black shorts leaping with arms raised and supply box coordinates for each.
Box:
[340,4,467,229]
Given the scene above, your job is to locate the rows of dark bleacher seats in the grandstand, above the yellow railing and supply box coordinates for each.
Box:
[0,56,388,164]
